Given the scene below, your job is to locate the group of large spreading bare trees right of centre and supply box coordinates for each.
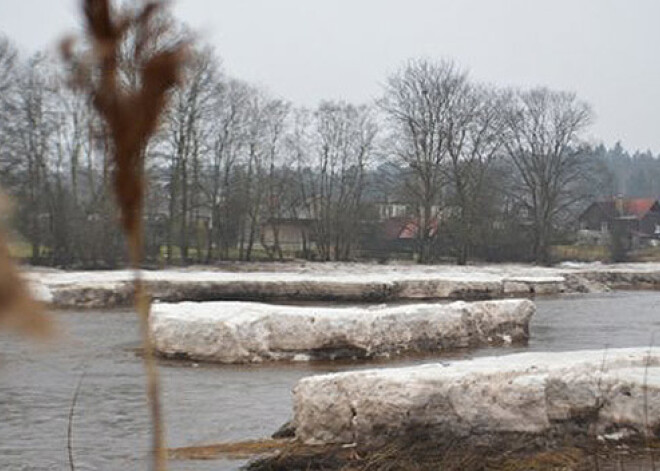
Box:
[380,61,595,264]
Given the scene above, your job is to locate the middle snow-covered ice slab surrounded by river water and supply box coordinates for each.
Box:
[150,299,535,363]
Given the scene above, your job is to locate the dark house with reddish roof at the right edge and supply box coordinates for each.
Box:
[578,197,660,249]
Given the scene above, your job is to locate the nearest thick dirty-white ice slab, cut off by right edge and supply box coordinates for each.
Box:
[293,348,660,445]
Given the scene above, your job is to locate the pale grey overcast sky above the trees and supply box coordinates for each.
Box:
[0,0,660,153]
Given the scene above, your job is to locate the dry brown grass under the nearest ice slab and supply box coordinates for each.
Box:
[240,436,658,471]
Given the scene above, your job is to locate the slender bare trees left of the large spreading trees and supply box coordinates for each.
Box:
[0,34,377,266]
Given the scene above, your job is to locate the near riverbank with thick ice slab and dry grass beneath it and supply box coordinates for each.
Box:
[245,348,660,470]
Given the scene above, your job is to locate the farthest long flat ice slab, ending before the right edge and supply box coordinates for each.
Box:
[29,264,566,308]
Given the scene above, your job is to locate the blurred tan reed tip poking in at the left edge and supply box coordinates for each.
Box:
[0,195,53,339]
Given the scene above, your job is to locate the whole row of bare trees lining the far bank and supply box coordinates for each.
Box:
[0,28,616,266]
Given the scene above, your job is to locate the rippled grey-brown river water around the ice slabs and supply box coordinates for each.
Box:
[0,291,660,471]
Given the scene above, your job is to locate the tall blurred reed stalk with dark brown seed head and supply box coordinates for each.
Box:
[62,0,185,471]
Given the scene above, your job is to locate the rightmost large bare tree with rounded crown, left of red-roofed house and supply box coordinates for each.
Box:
[504,88,592,264]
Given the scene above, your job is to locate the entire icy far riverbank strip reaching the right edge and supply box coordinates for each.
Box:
[26,263,660,308]
